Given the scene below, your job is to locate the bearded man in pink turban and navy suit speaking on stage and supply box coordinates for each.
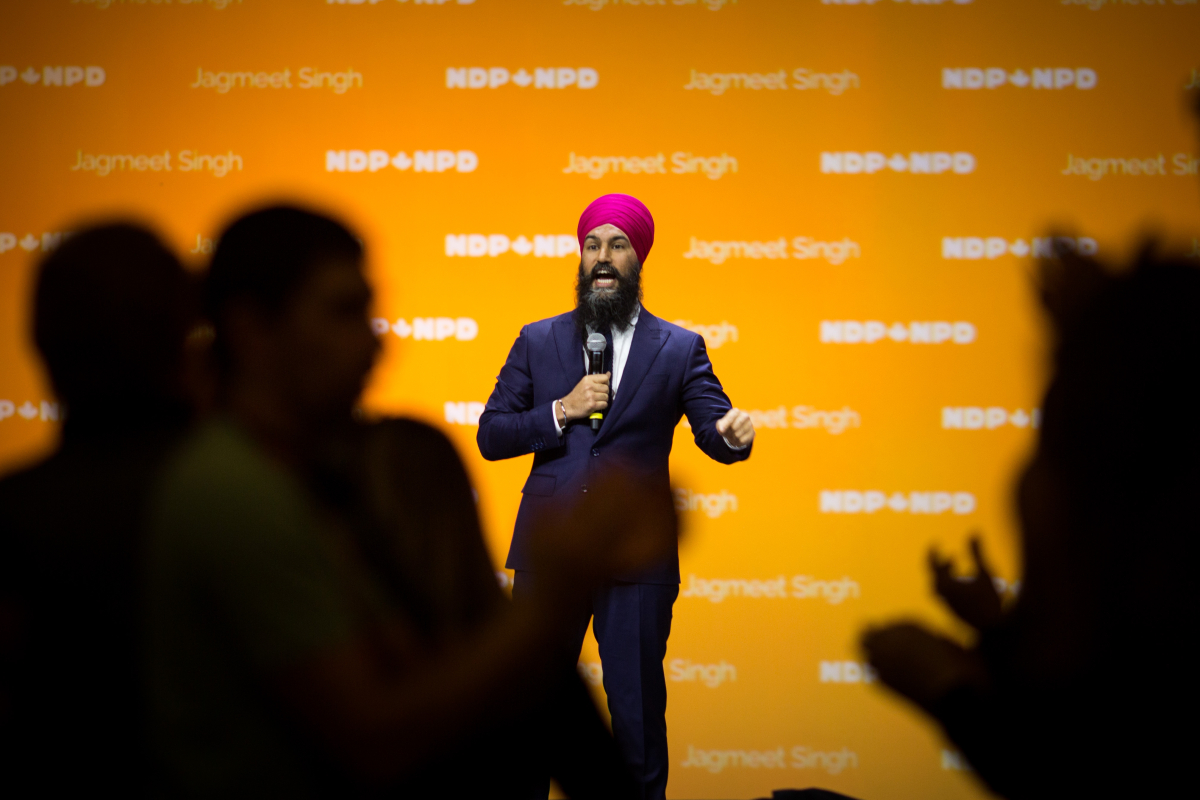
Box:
[479,194,754,799]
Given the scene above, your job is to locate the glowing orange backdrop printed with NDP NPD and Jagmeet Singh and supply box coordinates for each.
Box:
[0,0,1200,798]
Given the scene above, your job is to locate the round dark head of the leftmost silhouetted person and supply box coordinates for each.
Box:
[34,223,196,431]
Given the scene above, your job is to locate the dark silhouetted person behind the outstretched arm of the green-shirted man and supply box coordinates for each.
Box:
[316,419,635,798]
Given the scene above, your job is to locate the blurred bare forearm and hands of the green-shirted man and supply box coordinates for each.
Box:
[274,471,678,798]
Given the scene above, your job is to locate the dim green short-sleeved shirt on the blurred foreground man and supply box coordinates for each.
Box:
[146,420,356,798]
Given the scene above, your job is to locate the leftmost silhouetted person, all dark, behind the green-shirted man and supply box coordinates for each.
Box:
[0,224,193,796]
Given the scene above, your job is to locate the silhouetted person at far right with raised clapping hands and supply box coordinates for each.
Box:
[864,251,1200,799]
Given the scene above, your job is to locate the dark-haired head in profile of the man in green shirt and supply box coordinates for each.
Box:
[205,206,378,419]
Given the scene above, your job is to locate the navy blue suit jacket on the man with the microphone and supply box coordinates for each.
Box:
[478,307,750,583]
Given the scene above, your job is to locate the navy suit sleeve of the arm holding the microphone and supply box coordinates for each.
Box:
[476,326,563,461]
